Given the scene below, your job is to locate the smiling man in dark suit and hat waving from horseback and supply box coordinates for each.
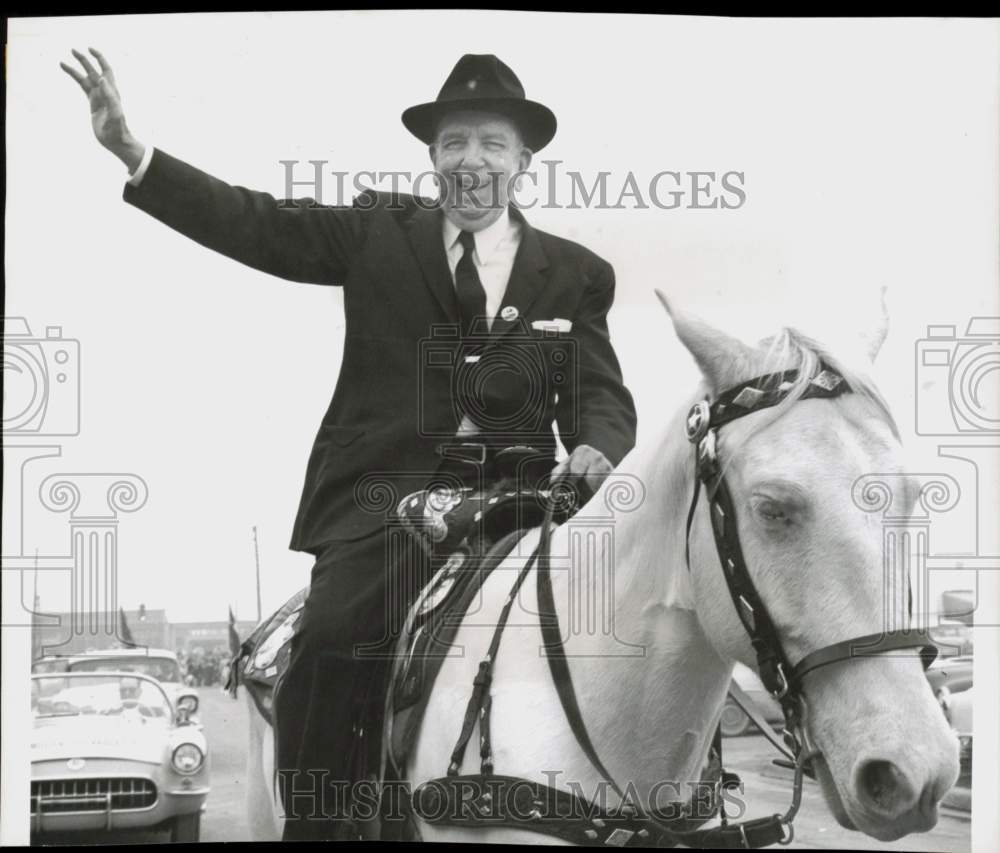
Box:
[63,50,636,839]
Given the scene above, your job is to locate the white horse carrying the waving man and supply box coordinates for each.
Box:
[250,300,959,844]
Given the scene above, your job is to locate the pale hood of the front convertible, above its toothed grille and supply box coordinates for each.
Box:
[31,716,170,764]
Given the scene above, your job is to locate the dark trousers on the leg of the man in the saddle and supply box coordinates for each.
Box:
[274,526,427,840]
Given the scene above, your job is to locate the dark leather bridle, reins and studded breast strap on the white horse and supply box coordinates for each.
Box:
[413,365,937,849]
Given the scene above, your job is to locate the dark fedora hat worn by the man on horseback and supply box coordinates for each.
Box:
[402,53,556,151]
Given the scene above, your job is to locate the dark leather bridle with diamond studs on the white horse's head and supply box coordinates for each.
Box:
[685,365,937,731]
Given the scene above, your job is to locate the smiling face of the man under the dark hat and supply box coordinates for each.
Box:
[430,111,531,231]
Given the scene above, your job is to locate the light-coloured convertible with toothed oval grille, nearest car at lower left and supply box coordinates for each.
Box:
[31,672,209,841]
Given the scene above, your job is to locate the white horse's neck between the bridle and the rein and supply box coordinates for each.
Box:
[552,418,731,799]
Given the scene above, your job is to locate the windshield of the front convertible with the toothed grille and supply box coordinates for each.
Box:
[31,673,173,722]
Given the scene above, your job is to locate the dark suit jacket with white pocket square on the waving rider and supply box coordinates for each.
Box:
[124,150,636,551]
